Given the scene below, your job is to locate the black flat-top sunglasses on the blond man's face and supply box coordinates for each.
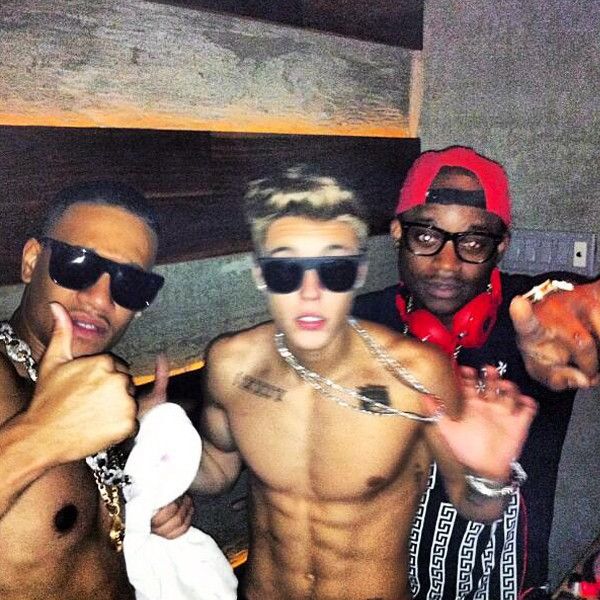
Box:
[257,253,365,294]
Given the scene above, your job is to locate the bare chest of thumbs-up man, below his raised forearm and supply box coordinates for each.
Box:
[0,462,134,600]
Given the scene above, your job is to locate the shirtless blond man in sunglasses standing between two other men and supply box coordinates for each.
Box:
[193,170,535,600]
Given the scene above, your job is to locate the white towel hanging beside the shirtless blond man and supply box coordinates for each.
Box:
[123,403,237,600]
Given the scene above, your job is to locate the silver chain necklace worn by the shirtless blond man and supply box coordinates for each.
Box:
[274,317,443,423]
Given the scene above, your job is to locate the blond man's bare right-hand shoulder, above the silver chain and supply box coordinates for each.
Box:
[360,321,456,404]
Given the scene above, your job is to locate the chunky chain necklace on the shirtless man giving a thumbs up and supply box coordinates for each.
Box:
[0,321,131,552]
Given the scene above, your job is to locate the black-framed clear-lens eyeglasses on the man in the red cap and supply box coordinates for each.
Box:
[400,221,503,264]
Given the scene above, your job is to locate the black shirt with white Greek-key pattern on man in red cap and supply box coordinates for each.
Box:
[352,273,575,600]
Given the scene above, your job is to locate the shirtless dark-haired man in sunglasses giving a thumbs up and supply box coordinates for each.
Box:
[0,184,189,600]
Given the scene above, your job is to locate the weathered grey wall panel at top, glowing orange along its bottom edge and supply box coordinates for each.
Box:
[0,0,418,137]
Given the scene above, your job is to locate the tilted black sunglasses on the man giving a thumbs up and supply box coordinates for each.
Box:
[40,237,165,310]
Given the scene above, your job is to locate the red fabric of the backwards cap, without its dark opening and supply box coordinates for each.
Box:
[396,146,511,226]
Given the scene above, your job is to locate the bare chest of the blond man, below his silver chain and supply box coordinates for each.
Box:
[229,385,428,500]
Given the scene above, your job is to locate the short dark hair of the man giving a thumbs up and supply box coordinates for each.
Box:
[41,181,160,237]
